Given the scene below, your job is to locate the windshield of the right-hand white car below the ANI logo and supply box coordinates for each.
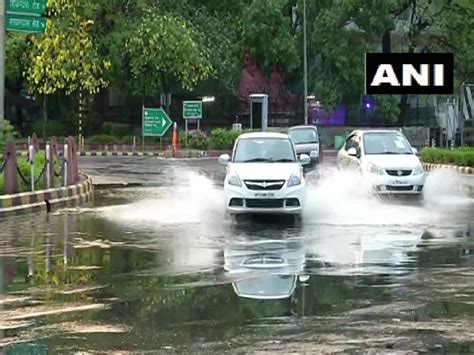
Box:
[364,132,413,155]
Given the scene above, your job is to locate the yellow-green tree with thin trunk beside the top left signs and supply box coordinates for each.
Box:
[23,0,110,136]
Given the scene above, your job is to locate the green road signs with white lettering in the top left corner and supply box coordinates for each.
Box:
[5,0,47,33]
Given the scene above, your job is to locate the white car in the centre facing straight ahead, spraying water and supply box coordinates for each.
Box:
[219,132,310,216]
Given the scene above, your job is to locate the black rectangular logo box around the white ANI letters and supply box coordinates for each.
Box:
[365,53,454,95]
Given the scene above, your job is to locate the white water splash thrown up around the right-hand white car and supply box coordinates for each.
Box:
[304,170,473,227]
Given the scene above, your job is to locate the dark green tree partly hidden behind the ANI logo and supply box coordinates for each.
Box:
[308,0,403,123]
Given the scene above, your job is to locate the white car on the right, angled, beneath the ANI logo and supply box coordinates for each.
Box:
[337,130,426,196]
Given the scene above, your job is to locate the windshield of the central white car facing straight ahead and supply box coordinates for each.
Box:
[234,138,296,163]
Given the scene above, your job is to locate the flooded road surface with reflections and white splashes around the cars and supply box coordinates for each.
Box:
[0,158,474,354]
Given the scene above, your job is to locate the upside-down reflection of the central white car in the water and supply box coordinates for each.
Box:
[224,241,307,300]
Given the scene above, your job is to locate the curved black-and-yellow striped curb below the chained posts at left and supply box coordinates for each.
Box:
[0,173,94,218]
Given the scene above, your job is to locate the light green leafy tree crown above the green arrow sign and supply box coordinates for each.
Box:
[125,7,212,97]
